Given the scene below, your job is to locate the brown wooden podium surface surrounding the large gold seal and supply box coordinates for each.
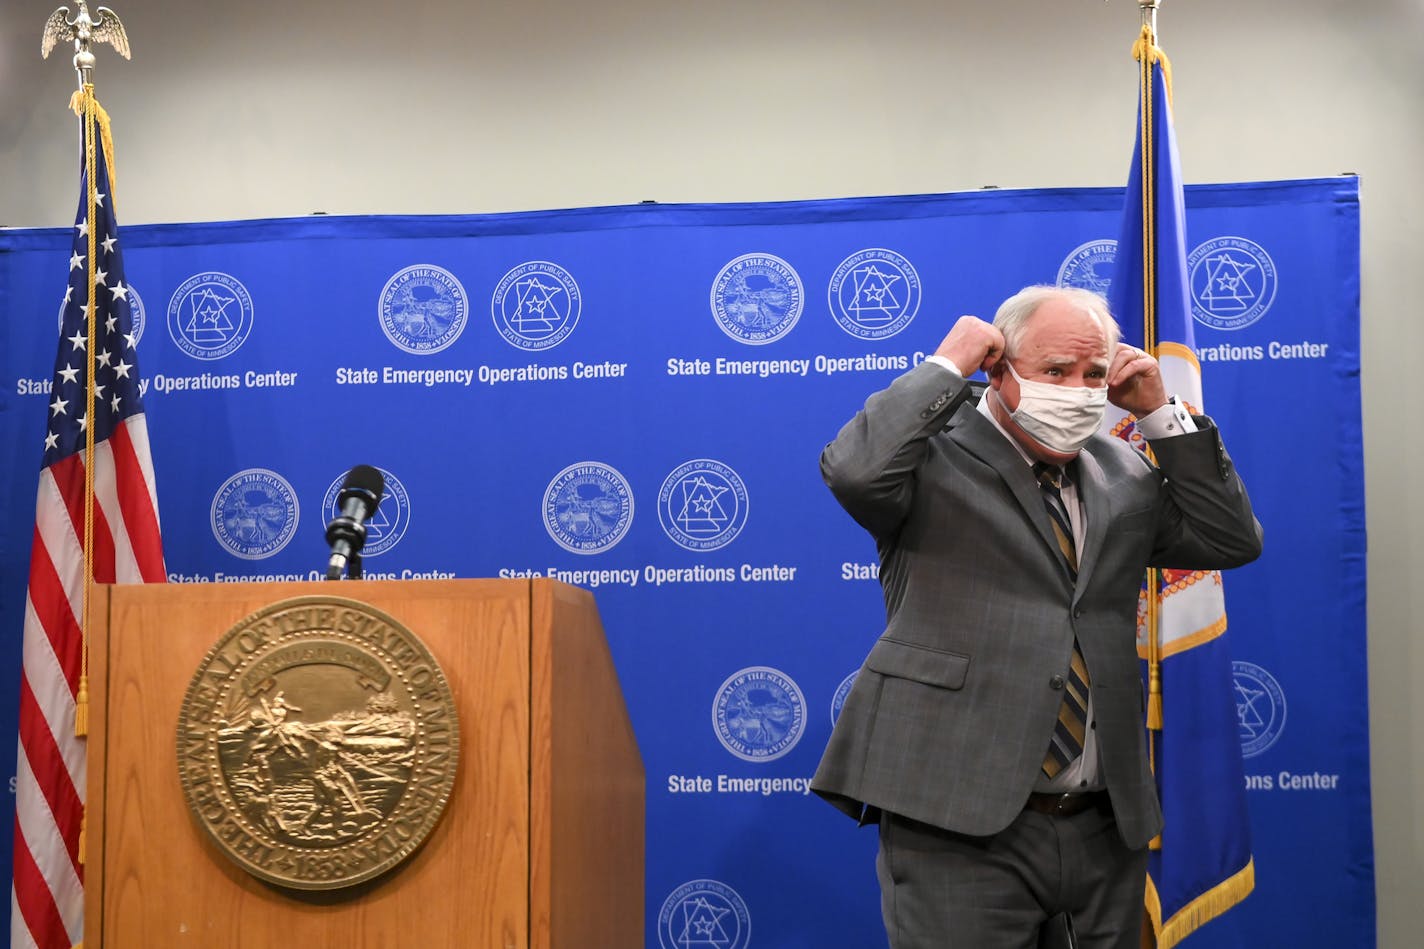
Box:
[84,580,644,949]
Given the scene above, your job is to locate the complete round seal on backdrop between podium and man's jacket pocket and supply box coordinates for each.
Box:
[712,665,806,762]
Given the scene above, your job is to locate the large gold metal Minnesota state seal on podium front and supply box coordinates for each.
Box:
[178,596,460,889]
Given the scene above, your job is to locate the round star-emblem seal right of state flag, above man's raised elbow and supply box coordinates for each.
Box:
[1186,237,1276,329]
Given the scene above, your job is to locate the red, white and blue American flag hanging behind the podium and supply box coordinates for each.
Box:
[10,111,164,949]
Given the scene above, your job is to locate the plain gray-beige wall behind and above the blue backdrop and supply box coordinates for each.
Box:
[0,0,1424,948]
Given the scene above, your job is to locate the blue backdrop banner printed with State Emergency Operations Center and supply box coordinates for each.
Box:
[0,178,1374,949]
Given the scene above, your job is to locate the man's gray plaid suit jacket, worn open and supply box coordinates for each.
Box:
[812,365,1262,848]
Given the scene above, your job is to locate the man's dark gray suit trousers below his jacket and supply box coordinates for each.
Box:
[876,809,1148,949]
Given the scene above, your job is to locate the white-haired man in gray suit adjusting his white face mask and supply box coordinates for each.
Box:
[812,286,1262,949]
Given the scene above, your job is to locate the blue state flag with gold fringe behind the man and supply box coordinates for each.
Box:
[1108,27,1255,949]
